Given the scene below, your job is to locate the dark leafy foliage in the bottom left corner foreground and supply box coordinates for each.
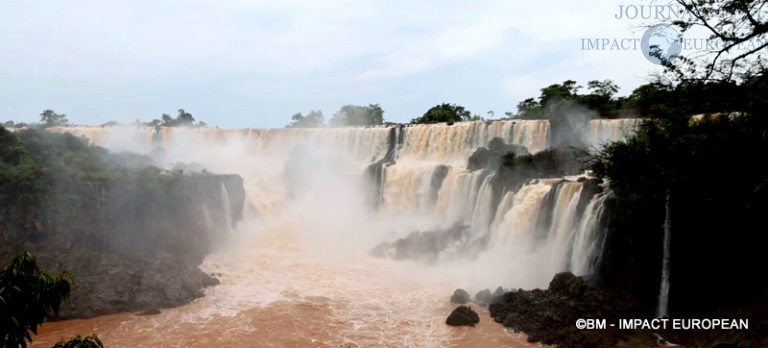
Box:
[0,253,72,347]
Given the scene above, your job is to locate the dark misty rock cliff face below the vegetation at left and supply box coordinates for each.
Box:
[0,174,245,319]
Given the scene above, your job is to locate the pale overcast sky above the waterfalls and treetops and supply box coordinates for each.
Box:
[0,0,656,127]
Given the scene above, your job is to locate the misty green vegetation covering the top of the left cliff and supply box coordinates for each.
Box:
[0,129,166,255]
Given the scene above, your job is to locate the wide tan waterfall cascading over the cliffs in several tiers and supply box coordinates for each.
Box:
[51,119,640,287]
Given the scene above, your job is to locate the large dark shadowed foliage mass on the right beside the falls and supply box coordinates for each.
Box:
[591,99,768,310]
